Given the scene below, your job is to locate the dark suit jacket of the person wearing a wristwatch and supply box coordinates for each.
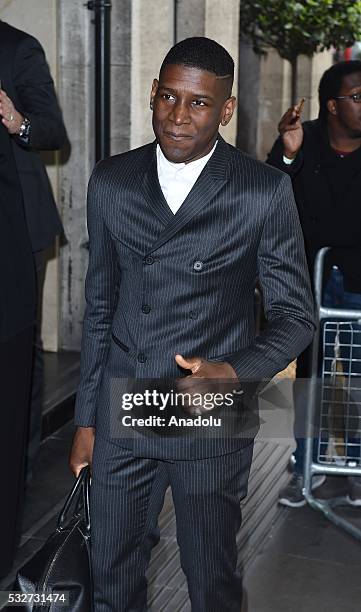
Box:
[0,21,66,251]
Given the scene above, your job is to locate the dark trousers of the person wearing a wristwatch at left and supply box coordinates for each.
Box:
[27,251,47,480]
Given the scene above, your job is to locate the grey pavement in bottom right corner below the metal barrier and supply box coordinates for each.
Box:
[242,477,361,612]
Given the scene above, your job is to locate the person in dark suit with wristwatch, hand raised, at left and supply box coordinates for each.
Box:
[0,21,66,471]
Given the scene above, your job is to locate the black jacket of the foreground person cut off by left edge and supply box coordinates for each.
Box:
[0,124,35,342]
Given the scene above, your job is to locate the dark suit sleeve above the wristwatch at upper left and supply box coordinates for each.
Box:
[13,36,66,151]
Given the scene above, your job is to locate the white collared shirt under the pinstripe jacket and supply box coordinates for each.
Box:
[157,140,218,214]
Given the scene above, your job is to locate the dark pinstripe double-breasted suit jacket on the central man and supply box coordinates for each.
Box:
[75,138,313,459]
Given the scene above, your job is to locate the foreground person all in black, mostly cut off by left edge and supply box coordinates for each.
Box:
[0,125,35,577]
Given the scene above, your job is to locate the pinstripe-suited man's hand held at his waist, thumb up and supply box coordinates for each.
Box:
[175,355,238,414]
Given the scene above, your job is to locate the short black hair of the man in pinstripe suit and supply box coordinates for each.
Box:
[159,36,234,93]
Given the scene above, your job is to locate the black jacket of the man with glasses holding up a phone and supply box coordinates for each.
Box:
[267,120,361,293]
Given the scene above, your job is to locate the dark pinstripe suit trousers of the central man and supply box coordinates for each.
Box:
[91,436,253,612]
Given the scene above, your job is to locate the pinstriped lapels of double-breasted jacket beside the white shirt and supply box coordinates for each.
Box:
[148,136,230,252]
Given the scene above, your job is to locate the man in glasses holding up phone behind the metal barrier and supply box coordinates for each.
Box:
[267,60,361,507]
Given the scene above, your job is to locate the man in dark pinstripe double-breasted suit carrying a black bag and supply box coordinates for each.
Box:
[70,38,313,612]
